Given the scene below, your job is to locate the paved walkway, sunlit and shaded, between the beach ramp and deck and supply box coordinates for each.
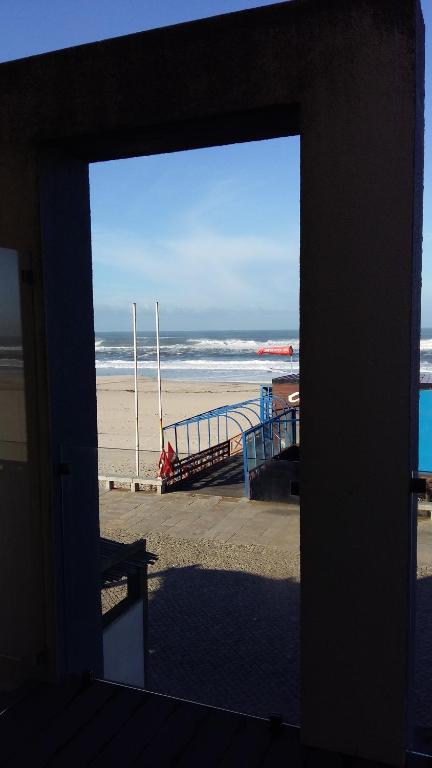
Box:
[100,491,432,734]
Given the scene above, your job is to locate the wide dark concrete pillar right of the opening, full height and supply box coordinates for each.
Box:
[300,2,423,763]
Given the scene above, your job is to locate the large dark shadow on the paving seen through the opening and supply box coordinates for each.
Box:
[148,565,300,724]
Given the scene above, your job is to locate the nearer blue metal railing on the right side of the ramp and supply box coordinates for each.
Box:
[243,408,300,495]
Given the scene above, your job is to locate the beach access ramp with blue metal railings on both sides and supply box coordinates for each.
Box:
[160,387,300,498]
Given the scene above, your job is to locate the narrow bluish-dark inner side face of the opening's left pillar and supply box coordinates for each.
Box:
[39,149,102,674]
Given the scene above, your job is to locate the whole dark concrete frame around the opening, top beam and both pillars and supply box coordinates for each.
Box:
[0,0,423,765]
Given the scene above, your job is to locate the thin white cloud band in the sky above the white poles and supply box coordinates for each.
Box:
[93,228,299,310]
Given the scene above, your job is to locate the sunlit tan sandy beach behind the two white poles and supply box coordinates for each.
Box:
[97,376,260,477]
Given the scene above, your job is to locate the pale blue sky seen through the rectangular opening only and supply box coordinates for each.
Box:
[91,137,299,330]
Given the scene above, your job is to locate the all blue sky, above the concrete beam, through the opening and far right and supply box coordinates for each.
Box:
[0,0,432,331]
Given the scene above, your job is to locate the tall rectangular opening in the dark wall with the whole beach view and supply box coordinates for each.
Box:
[90,137,300,723]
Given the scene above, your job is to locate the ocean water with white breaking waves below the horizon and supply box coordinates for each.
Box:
[95,328,432,384]
